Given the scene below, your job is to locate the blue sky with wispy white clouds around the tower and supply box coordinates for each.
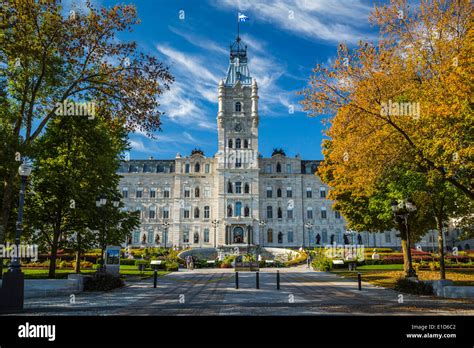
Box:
[69,0,376,159]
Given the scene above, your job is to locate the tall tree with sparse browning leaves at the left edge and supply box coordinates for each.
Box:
[0,0,173,274]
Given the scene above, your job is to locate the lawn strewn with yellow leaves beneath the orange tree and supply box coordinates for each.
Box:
[332,265,474,288]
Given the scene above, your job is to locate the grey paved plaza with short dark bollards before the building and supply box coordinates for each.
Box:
[8,266,474,316]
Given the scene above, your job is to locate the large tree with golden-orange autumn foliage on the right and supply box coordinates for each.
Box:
[301,0,474,278]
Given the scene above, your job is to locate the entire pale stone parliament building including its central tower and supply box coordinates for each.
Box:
[116,39,442,247]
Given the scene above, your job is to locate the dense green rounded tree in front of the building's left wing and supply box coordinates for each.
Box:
[25,114,131,278]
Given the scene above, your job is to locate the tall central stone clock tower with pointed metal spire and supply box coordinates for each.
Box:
[215,37,260,245]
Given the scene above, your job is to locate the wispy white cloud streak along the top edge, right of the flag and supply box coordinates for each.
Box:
[213,0,371,43]
